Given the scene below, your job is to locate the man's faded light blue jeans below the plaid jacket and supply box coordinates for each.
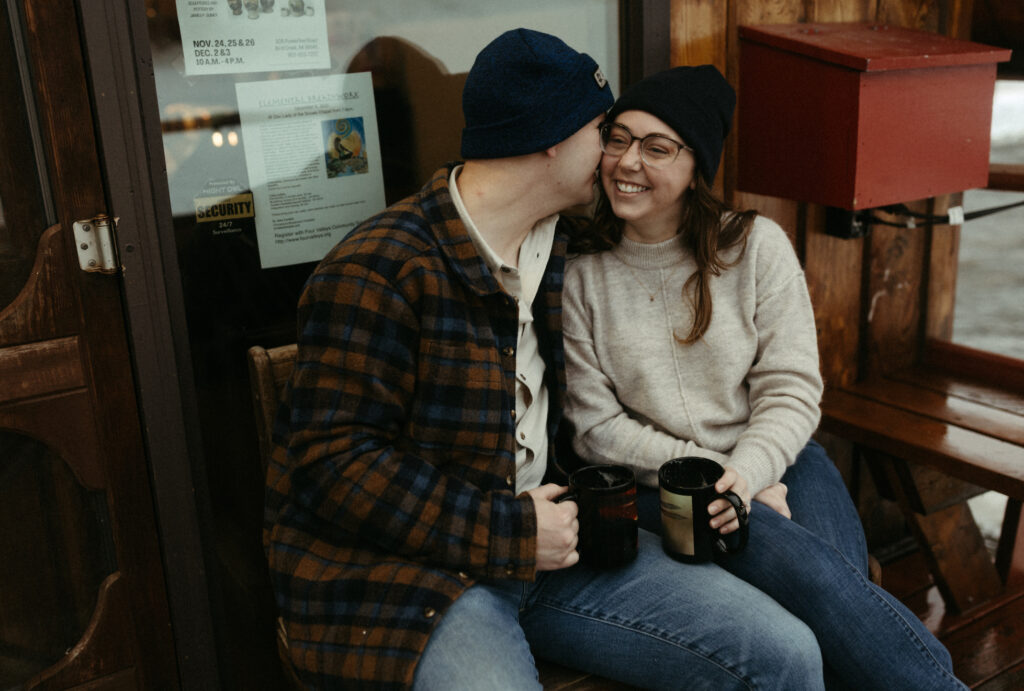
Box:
[414,530,822,691]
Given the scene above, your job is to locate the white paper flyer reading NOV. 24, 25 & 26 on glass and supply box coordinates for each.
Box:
[177,0,331,75]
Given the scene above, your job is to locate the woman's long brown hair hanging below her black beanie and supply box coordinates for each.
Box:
[566,174,758,344]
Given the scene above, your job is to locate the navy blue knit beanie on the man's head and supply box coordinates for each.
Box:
[462,29,614,159]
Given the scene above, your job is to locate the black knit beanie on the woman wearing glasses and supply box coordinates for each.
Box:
[607,64,736,185]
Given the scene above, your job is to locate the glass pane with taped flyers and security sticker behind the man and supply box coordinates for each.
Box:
[145,0,622,688]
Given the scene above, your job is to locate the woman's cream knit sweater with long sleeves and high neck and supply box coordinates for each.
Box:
[564,217,822,495]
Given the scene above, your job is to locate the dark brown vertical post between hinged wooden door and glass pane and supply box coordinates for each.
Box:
[76,0,220,689]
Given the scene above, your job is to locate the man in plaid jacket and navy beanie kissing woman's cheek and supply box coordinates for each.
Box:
[264,29,821,689]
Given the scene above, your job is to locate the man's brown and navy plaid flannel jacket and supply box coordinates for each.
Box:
[264,167,565,688]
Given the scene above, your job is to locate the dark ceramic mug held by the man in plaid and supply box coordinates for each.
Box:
[555,465,639,568]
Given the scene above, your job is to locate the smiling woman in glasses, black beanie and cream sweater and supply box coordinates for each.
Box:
[564,66,965,689]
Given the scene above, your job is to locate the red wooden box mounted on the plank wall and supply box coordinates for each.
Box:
[737,24,1011,210]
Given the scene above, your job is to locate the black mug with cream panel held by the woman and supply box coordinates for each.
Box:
[657,456,750,563]
